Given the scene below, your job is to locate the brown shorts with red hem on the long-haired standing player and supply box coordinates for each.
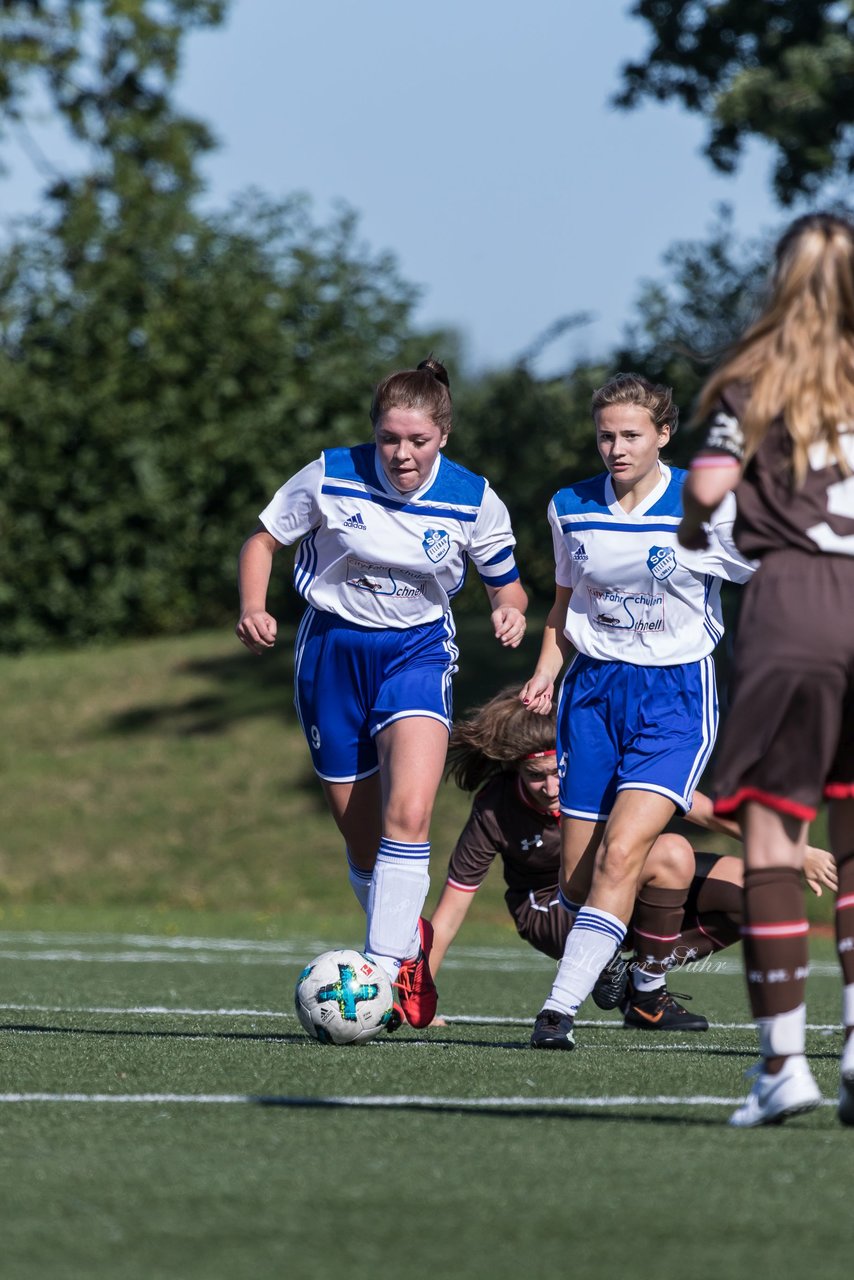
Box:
[714,550,854,822]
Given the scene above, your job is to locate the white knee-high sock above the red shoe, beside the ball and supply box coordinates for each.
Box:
[365,836,430,982]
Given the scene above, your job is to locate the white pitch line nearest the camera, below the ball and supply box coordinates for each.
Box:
[0,1093,837,1111]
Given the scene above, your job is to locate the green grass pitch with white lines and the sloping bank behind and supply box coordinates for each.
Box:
[0,632,854,1280]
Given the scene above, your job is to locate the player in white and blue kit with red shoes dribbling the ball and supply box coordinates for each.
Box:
[237,358,528,1027]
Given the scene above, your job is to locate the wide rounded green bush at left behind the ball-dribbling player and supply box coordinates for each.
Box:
[0,189,450,649]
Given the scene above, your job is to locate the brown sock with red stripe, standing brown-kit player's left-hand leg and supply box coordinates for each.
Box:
[741,867,809,1074]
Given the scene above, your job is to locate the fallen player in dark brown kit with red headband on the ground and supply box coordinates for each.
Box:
[431,689,835,1030]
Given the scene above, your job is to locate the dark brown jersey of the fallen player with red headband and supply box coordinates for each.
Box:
[448,771,561,893]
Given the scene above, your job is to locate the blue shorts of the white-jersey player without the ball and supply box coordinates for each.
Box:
[557,654,718,822]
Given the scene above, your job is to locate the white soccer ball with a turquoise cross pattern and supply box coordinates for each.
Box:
[293,950,393,1044]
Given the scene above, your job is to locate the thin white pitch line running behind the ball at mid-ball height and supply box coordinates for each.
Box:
[0,1001,842,1034]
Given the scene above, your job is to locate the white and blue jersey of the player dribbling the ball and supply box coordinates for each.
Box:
[260,444,519,628]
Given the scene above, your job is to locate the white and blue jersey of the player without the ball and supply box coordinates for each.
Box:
[548,462,754,667]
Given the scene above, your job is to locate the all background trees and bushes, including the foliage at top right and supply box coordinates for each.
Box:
[0,0,854,652]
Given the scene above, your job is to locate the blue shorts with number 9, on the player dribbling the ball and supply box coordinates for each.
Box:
[293,608,460,782]
